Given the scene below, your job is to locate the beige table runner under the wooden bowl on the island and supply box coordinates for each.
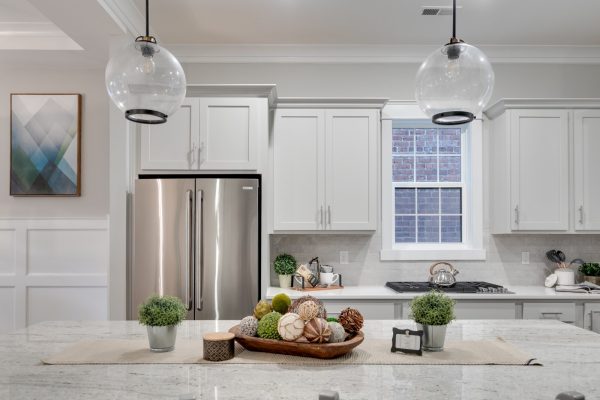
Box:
[42,338,541,365]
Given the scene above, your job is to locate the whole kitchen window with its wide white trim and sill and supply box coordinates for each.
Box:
[381,101,485,260]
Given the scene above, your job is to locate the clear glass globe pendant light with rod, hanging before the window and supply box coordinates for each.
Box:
[415,0,494,125]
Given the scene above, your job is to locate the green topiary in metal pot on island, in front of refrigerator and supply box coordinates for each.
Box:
[138,295,187,352]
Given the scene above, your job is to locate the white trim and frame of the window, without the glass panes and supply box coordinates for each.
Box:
[380,101,486,261]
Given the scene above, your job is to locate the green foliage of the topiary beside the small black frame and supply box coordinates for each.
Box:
[410,290,455,325]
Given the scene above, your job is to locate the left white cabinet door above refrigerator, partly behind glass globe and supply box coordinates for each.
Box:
[140,98,198,170]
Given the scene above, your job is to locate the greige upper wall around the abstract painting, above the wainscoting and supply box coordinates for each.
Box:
[0,68,108,218]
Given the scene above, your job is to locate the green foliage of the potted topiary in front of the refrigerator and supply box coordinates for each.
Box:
[138,295,187,326]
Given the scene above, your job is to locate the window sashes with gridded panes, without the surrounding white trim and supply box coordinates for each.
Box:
[392,123,465,243]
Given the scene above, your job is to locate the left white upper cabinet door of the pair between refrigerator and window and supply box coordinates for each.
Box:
[273,110,325,230]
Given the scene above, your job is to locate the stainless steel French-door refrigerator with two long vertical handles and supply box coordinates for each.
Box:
[128,178,260,319]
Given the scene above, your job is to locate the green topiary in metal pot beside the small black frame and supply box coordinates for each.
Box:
[410,290,454,351]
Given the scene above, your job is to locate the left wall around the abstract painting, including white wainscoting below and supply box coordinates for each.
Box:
[0,67,109,333]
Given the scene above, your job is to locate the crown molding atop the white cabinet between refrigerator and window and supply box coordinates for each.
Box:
[275,97,389,110]
